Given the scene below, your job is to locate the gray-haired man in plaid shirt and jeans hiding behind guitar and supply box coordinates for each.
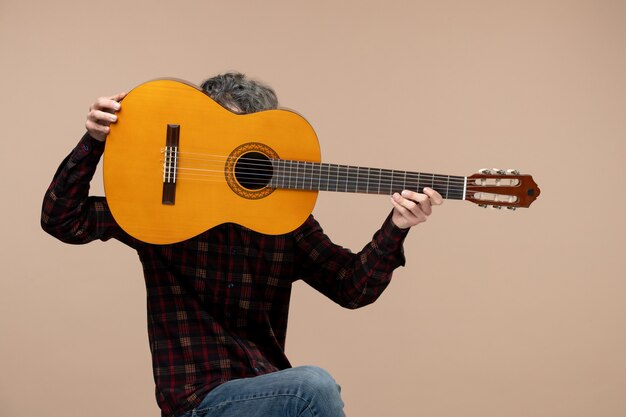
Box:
[41,73,442,417]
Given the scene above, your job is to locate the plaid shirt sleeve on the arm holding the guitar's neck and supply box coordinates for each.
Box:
[295,215,408,309]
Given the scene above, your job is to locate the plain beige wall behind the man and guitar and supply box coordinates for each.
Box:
[0,0,626,417]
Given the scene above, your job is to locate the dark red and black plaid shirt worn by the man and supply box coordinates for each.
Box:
[41,135,406,416]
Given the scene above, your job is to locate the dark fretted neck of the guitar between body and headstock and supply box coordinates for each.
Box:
[269,159,467,200]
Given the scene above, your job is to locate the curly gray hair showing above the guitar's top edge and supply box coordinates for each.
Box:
[201,72,278,114]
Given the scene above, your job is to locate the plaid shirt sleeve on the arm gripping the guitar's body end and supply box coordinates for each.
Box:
[41,134,137,246]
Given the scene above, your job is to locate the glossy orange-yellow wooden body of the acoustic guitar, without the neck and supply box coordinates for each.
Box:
[104,80,320,244]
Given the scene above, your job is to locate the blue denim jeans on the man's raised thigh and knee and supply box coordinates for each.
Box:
[182,366,345,417]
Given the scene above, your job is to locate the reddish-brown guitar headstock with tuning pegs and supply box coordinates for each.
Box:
[465,168,541,210]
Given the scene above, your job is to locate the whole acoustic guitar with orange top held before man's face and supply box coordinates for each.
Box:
[104,79,540,244]
